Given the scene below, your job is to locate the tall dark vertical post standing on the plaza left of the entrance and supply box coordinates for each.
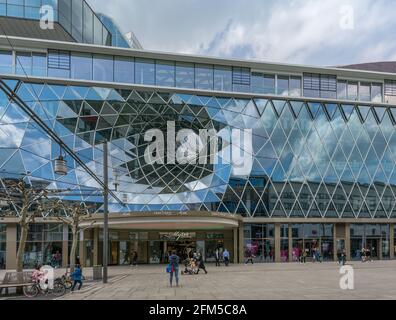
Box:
[103,141,109,283]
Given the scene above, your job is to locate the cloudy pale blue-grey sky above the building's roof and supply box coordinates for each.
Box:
[88,0,396,65]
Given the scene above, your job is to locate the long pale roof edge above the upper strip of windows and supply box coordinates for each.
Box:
[0,35,396,81]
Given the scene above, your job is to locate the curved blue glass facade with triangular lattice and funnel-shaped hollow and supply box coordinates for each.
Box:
[0,78,396,219]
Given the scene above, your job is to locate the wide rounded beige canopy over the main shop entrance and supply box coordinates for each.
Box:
[81,212,242,230]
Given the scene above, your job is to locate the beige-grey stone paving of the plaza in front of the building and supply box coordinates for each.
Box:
[57,261,396,300]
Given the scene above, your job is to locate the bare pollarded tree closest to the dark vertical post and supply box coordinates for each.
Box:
[53,201,96,271]
